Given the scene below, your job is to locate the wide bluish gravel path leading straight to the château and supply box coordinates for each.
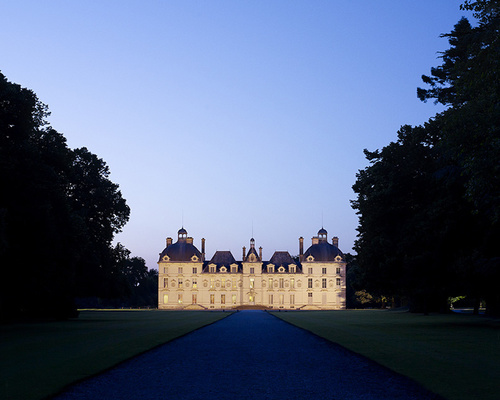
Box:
[51,310,440,400]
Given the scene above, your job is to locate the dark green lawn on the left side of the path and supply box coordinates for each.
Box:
[0,310,229,400]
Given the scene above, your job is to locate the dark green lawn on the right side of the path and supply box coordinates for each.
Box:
[273,310,500,400]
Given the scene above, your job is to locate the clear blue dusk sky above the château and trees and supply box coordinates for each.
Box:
[0,0,470,268]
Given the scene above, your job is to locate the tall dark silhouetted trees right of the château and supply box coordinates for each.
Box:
[352,1,500,314]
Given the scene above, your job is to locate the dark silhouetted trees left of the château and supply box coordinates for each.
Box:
[0,69,156,319]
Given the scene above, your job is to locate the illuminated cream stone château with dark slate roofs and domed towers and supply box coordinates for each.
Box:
[158,228,346,310]
